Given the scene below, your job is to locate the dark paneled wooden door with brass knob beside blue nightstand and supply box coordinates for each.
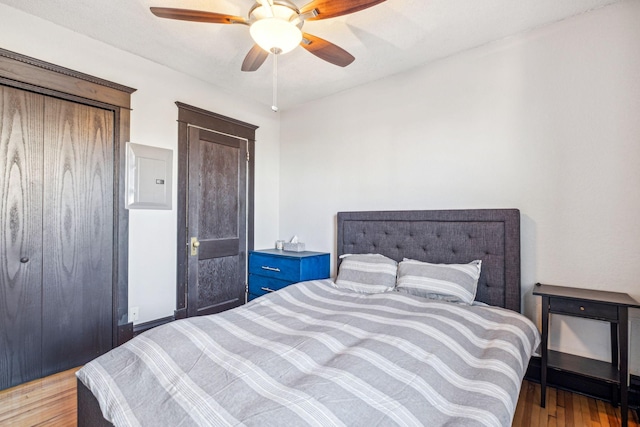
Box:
[187,127,248,316]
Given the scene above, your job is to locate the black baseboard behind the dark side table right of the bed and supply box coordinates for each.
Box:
[525,357,640,410]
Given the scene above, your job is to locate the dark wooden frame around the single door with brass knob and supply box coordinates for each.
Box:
[174,102,258,319]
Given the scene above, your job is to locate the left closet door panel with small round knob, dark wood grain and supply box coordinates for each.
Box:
[0,86,44,389]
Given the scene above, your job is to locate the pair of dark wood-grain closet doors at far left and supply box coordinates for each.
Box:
[0,86,115,389]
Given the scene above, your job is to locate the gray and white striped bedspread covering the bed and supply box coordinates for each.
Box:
[77,280,540,426]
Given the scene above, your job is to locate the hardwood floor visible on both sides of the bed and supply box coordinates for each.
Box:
[0,368,640,427]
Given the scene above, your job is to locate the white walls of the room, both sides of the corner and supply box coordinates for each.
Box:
[5,0,640,374]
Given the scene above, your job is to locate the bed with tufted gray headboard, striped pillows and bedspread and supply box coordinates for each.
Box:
[77,209,540,426]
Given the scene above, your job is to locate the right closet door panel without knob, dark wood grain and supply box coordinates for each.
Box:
[42,98,114,375]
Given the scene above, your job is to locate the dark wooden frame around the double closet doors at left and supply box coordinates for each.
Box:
[0,48,136,347]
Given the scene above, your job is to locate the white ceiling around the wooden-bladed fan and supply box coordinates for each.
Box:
[0,0,620,109]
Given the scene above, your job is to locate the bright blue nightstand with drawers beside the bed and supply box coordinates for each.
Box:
[249,249,329,301]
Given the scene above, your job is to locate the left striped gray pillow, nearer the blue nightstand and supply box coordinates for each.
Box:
[336,254,398,294]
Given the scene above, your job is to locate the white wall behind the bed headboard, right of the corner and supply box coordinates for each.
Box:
[274,0,640,374]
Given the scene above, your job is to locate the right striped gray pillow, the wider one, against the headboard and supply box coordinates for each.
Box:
[396,258,482,304]
